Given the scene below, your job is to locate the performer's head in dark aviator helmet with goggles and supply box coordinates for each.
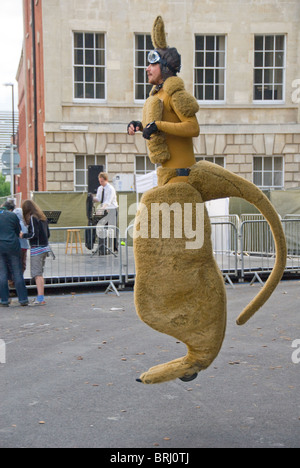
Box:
[147,47,181,85]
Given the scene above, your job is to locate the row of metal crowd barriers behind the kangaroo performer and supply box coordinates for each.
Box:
[24,216,300,292]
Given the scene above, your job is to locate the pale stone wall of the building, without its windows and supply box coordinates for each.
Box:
[38,0,300,191]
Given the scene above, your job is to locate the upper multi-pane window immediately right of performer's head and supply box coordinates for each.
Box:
[194,35,226,101]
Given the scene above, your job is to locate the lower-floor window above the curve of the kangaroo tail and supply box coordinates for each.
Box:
[253,156,284,189]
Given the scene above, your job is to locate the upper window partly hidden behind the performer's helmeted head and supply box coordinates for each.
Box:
[134,34,154,101]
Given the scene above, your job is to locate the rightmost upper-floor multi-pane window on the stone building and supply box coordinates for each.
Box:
[254,35,285,102]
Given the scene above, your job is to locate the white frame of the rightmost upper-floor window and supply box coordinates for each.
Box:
[252,33,287,105]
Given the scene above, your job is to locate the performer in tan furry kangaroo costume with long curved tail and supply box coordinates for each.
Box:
[127,16,286,384]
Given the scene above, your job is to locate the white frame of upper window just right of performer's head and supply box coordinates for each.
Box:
[193,33,227,105]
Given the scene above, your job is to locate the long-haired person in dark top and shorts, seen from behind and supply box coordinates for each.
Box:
[21,200,51,305]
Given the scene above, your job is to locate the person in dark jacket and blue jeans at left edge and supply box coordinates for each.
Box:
[0,201,28,307]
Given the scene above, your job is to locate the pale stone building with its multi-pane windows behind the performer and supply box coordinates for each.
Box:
[29,0,300,191]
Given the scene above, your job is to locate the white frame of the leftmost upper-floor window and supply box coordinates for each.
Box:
[72,30,107,104]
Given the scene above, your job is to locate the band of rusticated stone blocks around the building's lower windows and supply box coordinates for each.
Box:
[46,128,300,191]
